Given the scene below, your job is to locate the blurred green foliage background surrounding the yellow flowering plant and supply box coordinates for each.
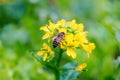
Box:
[0,0,120,80]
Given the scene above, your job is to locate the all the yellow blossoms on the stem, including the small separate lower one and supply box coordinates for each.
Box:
[37,19,95,71]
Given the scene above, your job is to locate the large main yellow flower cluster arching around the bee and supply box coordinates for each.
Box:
[38,20,95,60]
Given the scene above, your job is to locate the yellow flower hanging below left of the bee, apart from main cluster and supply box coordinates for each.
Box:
[37,43,54,61]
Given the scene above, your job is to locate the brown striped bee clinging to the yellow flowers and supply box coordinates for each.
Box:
[53,32,65,48]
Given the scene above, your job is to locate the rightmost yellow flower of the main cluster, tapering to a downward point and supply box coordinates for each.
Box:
[82,43,95,57]
